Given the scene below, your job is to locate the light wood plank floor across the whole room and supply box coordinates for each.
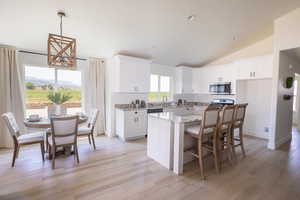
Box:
[0,133,300,200]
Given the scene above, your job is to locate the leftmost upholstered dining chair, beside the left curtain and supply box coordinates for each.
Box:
[2,112,45,167]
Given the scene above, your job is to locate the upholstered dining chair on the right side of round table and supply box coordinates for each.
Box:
[77,108,99,150]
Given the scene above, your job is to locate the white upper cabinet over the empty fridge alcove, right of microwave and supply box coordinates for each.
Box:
[234,55,273,80]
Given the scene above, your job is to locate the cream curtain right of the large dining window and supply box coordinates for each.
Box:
[82,58,105,134]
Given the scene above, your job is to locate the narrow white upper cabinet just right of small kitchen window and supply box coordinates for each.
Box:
[175,66,193,94]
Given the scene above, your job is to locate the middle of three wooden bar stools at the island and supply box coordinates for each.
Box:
[218,105,235,163]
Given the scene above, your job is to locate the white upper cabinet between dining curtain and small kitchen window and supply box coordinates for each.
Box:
[109,55,151,93]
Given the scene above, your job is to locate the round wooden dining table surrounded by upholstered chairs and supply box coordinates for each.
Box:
[24,115,88,159]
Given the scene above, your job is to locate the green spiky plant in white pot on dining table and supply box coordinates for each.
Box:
[48,91,72,118]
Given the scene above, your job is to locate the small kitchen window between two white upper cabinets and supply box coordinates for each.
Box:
[149,74,171,102]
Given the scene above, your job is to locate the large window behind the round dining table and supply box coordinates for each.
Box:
[25,66,82,117]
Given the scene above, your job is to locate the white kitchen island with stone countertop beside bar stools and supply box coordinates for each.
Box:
[147,106,206,175]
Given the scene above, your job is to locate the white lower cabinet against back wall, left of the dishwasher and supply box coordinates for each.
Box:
[116,109,147,141]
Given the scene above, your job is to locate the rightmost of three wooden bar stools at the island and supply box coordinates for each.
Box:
[231,104,248,158]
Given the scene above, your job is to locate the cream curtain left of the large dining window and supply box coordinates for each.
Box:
[0,46,25,147]
